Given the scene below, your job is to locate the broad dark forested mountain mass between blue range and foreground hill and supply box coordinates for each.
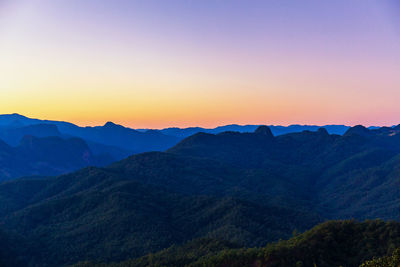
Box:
[0,125,400,266]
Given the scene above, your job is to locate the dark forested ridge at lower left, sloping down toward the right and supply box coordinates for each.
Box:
[0,160,319,265]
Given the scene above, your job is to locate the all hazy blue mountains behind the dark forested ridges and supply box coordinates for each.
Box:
[0,114,360,181]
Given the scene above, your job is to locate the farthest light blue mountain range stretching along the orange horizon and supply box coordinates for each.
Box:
[0,114,390,160]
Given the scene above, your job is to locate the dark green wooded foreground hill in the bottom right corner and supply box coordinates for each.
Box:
[192,221,400,267]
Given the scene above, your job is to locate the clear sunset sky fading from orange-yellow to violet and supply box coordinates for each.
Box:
[0,0,400,128]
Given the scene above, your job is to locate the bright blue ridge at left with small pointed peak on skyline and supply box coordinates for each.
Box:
[0,114,181,156]
